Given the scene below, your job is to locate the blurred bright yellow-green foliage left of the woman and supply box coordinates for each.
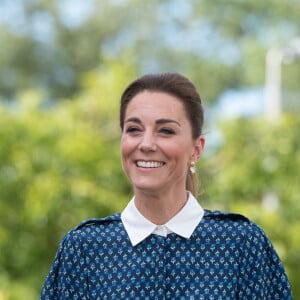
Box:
[0,62,134,299]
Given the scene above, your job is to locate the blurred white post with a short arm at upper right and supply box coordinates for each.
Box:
[265,37,300,121]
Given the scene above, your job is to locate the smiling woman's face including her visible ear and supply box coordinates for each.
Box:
[121,91,204,193]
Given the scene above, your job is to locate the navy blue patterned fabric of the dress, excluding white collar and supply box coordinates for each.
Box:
[40,211,292,300]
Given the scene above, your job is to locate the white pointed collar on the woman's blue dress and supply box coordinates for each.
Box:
[121,192,204,246]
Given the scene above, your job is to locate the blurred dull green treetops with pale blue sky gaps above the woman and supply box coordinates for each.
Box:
[0,0,300,103]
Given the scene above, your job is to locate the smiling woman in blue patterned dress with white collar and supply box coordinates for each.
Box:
[41,73,292,300]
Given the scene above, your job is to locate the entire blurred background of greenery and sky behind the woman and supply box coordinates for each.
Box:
[0,0,300,300]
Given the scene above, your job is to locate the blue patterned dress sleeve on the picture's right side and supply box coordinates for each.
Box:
[237,223,292,300]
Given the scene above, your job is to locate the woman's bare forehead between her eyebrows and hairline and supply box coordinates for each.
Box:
[126,91,186,118]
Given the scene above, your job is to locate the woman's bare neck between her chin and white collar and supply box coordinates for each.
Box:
[134,190,188,225]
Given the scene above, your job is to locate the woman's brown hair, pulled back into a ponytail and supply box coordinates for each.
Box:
[120,73,204,196]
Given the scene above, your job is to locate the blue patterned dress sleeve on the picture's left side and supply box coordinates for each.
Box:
[40,231,88,300]
